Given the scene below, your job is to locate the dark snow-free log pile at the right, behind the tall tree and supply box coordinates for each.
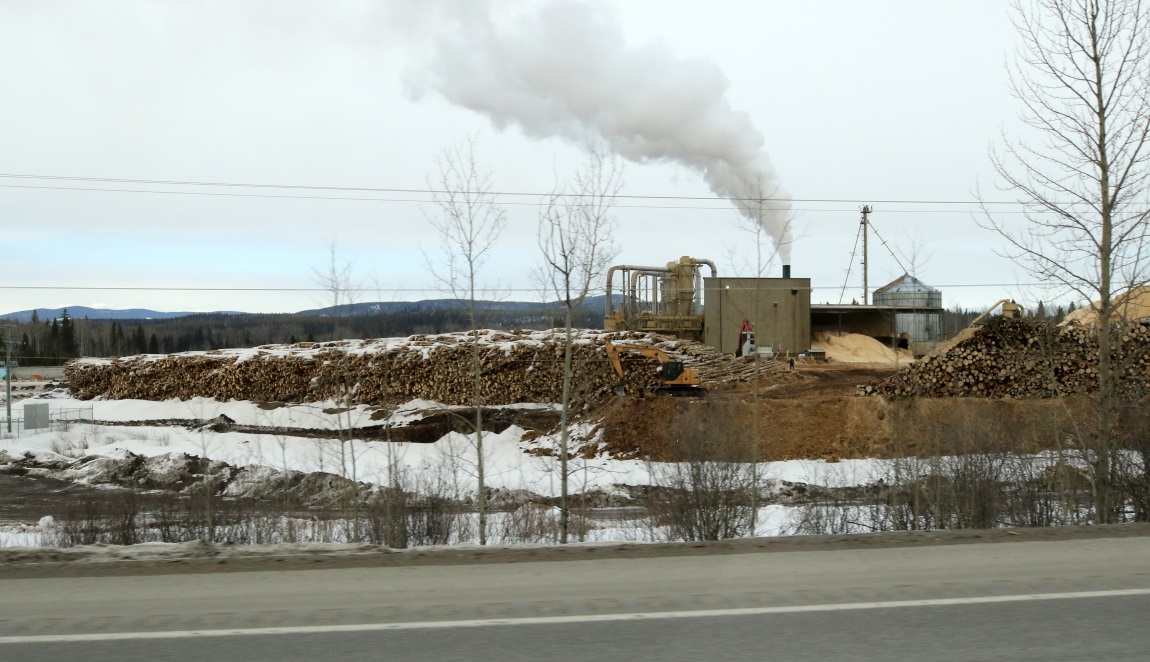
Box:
[863,320,1150,398]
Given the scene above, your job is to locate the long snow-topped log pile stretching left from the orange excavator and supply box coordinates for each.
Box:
[66,329,751,405]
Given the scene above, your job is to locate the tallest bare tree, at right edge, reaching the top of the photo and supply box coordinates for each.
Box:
[984,0,1150,522]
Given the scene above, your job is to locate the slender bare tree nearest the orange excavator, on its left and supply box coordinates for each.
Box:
[537,148,622,544]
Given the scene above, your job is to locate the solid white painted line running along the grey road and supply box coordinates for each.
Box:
[0,588,1150,645]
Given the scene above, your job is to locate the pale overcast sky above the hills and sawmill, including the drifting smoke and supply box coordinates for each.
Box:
[0,0,1050,311]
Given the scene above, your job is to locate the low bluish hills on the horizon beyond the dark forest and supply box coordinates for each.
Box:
[0,294,622,322]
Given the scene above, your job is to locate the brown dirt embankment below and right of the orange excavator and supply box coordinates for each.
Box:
[600,365,1108,461]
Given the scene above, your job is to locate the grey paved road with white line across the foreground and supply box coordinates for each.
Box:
[0,538,1150,661]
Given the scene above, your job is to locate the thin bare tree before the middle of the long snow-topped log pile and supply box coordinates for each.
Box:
[424,136,507,545]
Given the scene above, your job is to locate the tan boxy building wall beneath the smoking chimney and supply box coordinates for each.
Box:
[703,277,811,354]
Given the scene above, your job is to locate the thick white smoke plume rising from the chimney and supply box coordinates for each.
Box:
[411,0,791,264]
